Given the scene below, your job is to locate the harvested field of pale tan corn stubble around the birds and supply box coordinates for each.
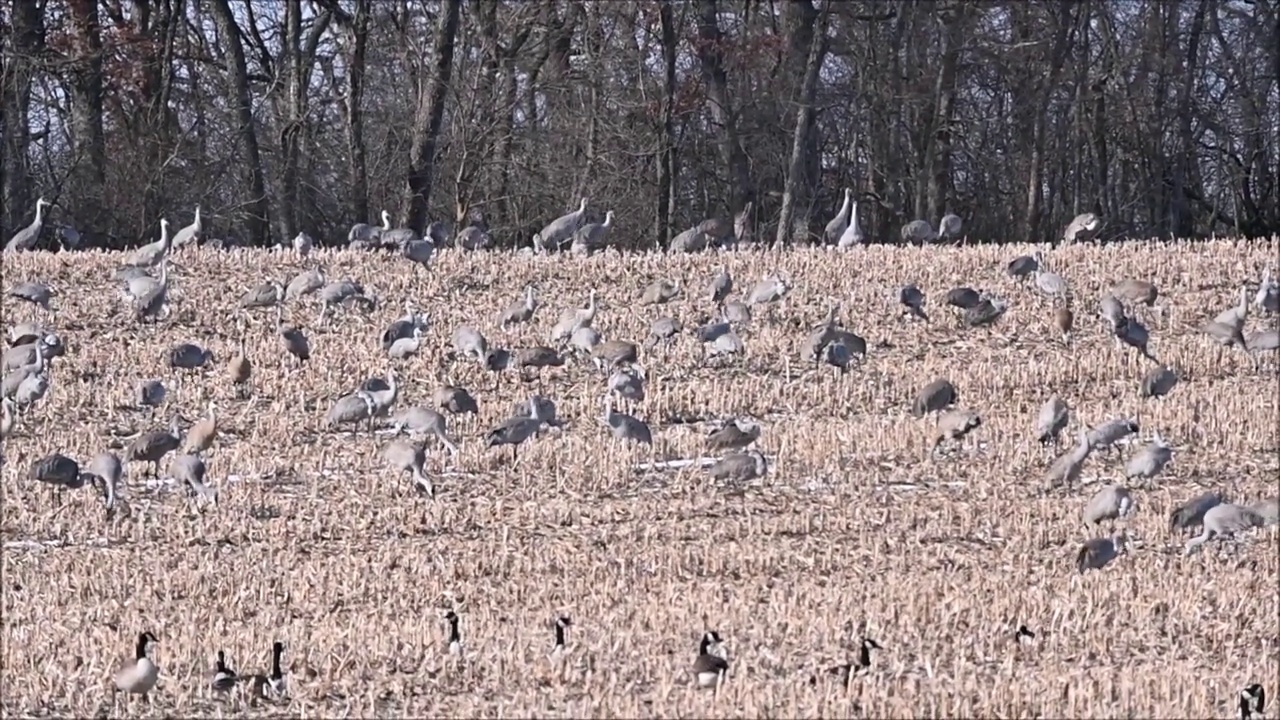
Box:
[0,242,1280,717]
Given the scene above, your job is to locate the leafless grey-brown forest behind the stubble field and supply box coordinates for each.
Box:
[0,0,1280,247]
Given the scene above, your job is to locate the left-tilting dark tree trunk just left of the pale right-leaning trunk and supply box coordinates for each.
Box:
[695,0,755,214]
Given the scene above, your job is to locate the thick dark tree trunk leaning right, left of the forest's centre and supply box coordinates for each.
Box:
[401,0,462,234]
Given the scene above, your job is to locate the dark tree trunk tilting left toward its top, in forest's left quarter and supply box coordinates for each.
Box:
[212,0,271,247]
